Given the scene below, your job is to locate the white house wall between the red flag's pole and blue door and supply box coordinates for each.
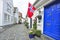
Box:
[32,7,44,33]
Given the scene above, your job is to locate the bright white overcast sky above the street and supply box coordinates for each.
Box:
[13,0,36,18]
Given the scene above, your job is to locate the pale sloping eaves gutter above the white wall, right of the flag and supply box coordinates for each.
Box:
[33,0,54,9]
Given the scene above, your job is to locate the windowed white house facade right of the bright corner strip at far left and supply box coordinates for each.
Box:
[2,0,13,25]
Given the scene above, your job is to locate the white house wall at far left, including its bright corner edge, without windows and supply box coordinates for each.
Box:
[0,0,13,26]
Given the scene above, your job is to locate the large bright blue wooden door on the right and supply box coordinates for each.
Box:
[43,1,60,40]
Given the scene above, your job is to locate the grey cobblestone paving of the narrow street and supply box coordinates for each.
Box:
[0,24,40,40]
